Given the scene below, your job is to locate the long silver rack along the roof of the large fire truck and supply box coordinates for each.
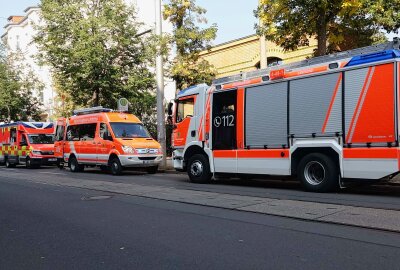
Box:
[212,37,400,85]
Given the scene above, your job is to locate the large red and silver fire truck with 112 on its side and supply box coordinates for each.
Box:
[168,38,400,192]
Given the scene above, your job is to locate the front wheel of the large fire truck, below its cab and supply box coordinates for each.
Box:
[187,154,212,184]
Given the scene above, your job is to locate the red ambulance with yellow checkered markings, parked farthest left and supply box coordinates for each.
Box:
[0,122,57,168]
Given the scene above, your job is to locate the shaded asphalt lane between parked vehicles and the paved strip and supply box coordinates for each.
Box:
[0,167,400,210]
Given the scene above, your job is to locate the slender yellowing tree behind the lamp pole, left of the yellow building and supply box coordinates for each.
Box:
[164,0,217,89]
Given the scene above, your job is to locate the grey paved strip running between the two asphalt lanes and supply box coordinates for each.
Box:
[2,172,400,232]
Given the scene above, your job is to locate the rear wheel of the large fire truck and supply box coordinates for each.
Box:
[297,153,340,192]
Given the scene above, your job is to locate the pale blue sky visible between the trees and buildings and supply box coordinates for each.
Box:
[0,0,258,44]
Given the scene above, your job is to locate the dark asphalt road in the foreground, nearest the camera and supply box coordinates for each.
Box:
[0,172,400,269]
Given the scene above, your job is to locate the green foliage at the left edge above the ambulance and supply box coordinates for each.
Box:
[0,47,43,122]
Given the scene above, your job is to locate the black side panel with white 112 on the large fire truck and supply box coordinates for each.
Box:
[212,91,237,150]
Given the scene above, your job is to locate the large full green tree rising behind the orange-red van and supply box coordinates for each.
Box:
[35,0,155,113]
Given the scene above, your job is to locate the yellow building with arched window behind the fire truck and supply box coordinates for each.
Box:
[201,35,317,78]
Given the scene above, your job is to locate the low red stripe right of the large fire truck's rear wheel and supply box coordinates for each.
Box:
[343,147,398,159]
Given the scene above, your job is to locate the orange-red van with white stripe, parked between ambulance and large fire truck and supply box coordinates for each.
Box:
[55,107,163,175]
